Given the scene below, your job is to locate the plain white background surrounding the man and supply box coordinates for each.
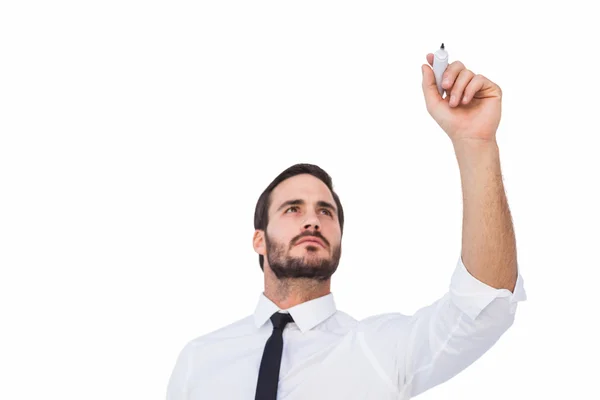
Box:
[0,0,600,400]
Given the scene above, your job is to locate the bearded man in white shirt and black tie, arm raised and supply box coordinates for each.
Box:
[167,54,526,400]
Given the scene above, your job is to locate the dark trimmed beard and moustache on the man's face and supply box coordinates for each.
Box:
[265,233,342,281]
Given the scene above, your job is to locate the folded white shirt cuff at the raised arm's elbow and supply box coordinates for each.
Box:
[450,254,527,319]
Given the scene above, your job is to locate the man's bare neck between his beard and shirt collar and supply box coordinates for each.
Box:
[263,265,331,310]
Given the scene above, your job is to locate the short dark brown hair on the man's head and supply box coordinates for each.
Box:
[254,164,344,271]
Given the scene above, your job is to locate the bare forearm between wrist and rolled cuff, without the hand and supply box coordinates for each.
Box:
[453,141,517,292]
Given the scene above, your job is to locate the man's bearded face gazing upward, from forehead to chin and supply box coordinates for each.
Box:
[265,174,342,281]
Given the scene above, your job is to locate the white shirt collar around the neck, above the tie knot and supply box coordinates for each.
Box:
[254,292,337,333]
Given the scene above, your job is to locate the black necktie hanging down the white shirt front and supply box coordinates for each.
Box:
[254,312,294,400]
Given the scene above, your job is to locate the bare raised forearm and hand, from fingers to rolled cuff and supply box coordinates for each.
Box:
[421,54,517,291]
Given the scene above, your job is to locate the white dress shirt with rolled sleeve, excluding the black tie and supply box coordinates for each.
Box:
[167,257,526,400]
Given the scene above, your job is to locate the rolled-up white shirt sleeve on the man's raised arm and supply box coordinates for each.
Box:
[399,256,527,397]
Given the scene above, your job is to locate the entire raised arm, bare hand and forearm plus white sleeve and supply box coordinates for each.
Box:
[354,54,526,399]
